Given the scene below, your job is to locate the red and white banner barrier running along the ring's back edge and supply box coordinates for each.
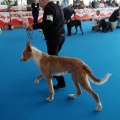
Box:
[0,7,117,26]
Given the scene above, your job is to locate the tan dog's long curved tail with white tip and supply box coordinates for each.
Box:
[83,64,111,85]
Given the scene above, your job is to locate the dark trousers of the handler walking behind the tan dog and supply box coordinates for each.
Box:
[46,35,65,85]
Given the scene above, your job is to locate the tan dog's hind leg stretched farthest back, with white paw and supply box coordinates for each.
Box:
[80,77,102,111]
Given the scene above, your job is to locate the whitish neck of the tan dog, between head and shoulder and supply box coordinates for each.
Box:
[31,47,42,66]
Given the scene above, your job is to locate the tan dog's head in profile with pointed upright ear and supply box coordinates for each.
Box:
[20,41,32,61]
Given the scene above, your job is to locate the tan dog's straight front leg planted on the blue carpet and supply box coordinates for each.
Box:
[46,77,54,102]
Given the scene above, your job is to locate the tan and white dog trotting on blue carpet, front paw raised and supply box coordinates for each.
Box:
[21,42,111,111]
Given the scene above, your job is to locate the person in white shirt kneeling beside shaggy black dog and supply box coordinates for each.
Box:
[92,10,101,31]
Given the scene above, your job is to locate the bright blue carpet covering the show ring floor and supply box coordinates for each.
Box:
[0,21,120,120]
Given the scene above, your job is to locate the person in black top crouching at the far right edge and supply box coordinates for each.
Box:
[109,7,120,28]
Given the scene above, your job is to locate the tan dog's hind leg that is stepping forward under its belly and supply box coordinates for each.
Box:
[68,75,82,98]
